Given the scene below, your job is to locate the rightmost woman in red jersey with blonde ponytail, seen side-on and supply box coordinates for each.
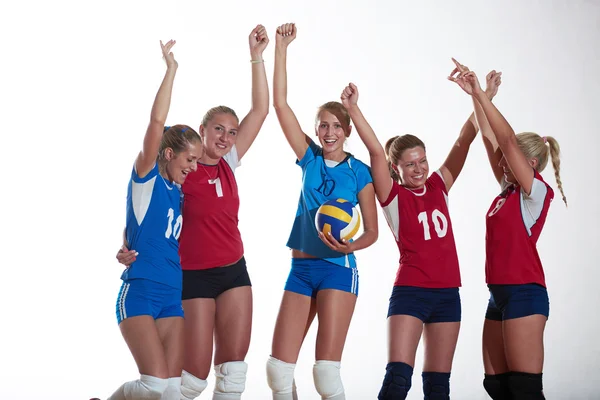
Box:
[449,60,567,400]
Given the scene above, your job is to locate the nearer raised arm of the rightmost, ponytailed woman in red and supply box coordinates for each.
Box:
[456,62,534,194]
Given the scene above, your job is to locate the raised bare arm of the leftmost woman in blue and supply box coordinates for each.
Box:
[135,40,178,178]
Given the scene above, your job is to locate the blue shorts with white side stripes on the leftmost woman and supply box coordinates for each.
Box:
[117,279,183,324]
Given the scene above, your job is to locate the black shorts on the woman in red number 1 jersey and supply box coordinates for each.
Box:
[181,257,252,300]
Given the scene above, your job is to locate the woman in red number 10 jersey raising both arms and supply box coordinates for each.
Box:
[342,74,497,400]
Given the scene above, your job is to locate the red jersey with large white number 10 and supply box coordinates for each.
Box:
[381,171,461,288]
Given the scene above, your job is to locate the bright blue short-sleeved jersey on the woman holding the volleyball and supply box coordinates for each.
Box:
[287,140,373,268]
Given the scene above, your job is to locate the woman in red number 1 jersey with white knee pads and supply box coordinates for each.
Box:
[117,25,269,400]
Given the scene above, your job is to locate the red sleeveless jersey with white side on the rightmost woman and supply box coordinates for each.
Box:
[485,170,554,287]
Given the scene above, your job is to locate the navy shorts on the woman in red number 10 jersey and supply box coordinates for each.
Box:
[388,286,462,324]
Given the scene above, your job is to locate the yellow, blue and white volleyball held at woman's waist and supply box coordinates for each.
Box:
[315,199,360,241]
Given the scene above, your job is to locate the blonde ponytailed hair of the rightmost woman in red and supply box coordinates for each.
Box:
[516,132,567,205]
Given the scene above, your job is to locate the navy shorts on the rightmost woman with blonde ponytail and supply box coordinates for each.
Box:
[485,283,550,321]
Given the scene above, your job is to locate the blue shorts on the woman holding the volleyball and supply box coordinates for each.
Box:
[284,258,358,297]
